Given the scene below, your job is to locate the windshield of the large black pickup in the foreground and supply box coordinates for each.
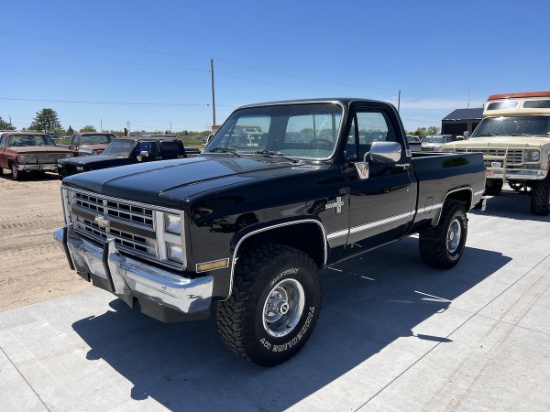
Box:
[205,103,342,160]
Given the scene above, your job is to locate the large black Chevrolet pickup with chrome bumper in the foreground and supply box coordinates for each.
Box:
[54,99,485,366]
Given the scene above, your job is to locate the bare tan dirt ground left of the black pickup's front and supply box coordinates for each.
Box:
[0,172,91,311]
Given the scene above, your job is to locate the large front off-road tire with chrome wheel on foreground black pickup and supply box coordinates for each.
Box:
[216,244,321,366]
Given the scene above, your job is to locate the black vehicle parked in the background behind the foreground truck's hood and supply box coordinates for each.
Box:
[57,135,200,178]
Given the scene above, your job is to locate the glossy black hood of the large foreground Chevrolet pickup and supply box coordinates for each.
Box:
[63,155,318,209]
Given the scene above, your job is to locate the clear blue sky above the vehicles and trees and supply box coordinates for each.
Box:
[0,0,550,131]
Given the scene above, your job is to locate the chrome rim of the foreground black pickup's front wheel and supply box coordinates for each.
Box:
[262,279,305,337]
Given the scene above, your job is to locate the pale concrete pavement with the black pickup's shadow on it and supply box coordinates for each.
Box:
[0,188,550,411]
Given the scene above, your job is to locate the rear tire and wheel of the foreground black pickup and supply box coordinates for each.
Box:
[419,202,468,269]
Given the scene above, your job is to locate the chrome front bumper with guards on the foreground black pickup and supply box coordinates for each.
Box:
[53,225,214,320]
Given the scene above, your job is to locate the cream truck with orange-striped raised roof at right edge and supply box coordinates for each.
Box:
[444,91,550,216]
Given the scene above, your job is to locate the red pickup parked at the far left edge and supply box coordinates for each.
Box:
[0,131,73,180]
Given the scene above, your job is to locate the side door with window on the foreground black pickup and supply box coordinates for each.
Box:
[345,108,417,250]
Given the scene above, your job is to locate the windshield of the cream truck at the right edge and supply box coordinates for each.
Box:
[471,116,550,138]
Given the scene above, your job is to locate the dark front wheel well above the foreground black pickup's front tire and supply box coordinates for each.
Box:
[238,222,325,267]
